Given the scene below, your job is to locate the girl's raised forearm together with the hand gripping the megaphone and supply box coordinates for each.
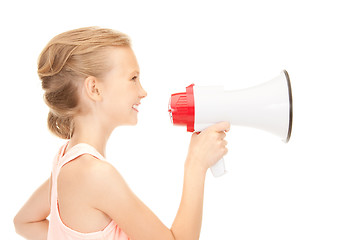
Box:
[171,122,230,240]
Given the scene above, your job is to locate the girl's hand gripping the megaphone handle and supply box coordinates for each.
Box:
[185,122,230,172]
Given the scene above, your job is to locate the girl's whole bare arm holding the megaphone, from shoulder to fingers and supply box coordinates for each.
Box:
[89,124,228,240]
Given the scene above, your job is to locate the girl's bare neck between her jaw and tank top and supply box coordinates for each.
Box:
[68,113,114,157]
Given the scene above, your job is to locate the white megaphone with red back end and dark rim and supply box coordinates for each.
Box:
[168,70,293,177]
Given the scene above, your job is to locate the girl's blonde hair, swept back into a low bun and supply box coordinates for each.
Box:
[38,27,131,139]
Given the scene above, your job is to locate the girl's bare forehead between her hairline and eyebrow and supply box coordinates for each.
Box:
[109,47,139,74]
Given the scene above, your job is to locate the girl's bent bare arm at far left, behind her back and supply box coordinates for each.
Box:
[14,179,50,240]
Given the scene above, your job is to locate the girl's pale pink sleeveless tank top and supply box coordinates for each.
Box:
[48,143,129,240]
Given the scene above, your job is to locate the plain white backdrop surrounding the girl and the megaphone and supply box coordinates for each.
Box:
[0,0,360,240]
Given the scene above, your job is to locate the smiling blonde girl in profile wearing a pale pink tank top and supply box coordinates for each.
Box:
[14,27,230,240]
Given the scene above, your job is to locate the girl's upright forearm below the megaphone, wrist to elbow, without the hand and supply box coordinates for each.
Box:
[171,159,206,240]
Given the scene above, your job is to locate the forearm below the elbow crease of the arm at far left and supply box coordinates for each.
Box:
[14,219,49,240]
